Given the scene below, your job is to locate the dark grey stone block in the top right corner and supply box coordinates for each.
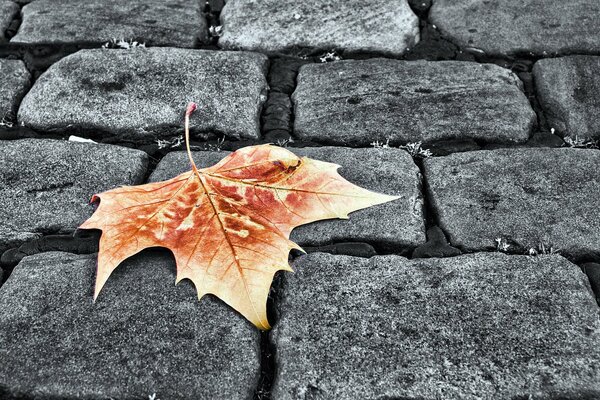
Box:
[429,0,600,56]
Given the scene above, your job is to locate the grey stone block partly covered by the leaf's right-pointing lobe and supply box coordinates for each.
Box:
[150,147,425,253]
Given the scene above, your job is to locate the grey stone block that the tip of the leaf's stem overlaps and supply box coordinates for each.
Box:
[18,48,268,141]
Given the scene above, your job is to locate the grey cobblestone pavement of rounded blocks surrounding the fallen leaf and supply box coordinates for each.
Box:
[0,0,600,400]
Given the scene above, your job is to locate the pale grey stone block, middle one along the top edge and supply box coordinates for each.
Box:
[219,0,419,56]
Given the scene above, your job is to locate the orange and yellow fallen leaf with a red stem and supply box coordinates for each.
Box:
[80,103,396,329]
